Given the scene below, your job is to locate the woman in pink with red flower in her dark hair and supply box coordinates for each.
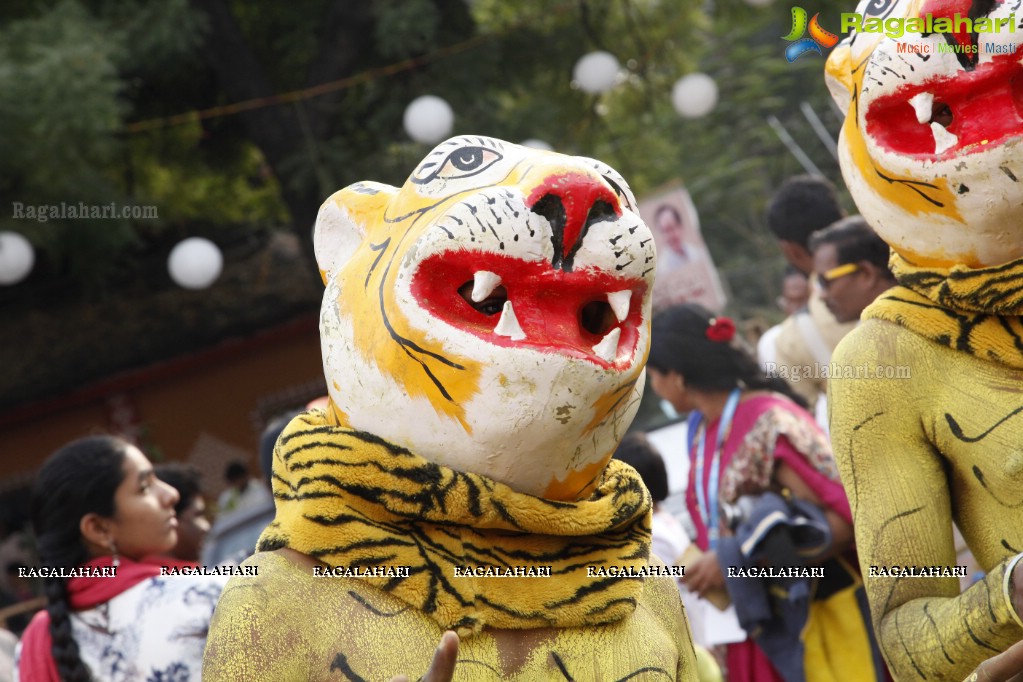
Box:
[647,304,884,682]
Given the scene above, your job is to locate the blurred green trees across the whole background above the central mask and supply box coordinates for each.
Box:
[0,0,848,312]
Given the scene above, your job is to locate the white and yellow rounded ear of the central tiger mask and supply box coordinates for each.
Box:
[313,182,398,284]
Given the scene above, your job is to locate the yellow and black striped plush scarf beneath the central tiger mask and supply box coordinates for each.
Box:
[259,410,651,633]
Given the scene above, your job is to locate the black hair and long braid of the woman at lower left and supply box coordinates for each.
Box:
[32,436,127,682]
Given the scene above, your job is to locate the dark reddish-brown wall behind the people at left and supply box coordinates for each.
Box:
[0,317,326,505]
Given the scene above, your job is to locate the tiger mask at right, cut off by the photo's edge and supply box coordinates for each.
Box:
[827,0,1023,267]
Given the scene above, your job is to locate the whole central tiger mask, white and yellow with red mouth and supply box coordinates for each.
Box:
[314,136,656,500]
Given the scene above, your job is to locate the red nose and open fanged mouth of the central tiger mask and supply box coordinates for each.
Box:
[411,166,649,368]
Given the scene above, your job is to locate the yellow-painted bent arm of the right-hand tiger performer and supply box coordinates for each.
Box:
[829,322,1023,680]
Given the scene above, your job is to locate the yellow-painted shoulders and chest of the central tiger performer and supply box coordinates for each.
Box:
[203,551,697,682]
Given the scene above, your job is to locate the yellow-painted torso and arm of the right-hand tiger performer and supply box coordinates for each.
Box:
[829,316,1023,680]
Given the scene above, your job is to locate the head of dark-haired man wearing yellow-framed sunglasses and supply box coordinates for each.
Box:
[810,216,895,322]
